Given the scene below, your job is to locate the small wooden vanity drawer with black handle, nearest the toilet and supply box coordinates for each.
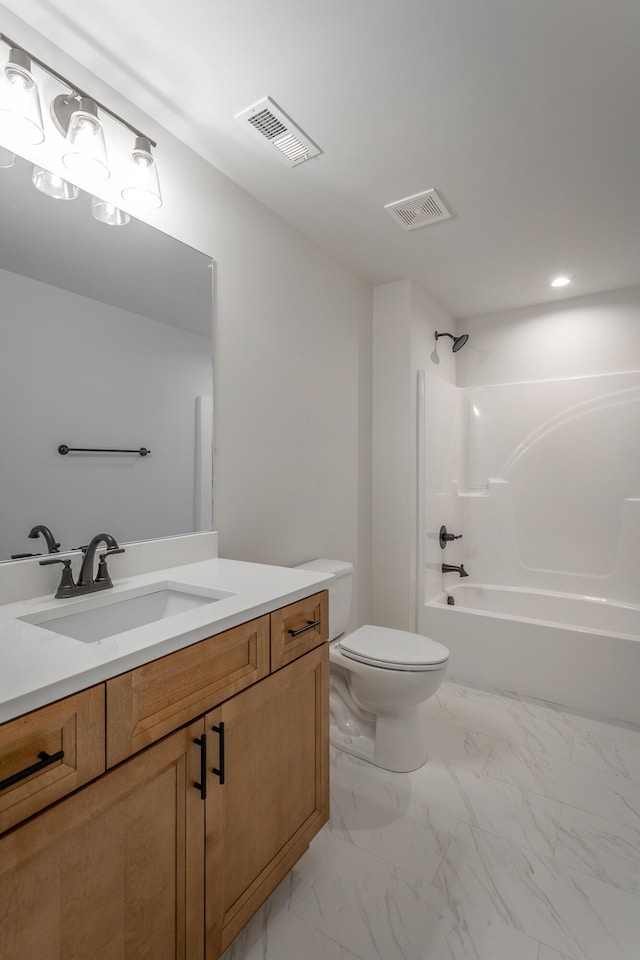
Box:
[271,590,329,671]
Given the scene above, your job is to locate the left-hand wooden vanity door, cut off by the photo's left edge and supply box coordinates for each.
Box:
[0,720,204,960]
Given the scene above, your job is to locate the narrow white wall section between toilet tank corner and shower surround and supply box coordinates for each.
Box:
[372,280,455,630]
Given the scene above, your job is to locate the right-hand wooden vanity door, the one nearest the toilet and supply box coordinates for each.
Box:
[205,643,329,960]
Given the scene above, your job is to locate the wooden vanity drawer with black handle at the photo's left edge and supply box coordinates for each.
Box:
[0,684,105,832]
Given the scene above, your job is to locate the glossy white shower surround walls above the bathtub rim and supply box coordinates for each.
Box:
[418,371,640,604]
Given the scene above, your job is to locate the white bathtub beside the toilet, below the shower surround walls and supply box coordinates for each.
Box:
[420,584,640,723]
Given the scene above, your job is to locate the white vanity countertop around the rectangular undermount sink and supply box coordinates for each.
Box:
[0,558,333,723]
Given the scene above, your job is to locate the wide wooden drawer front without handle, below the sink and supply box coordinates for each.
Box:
[107,616,269,767]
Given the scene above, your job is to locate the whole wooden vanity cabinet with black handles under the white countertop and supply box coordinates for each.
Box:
[0,592,329,960]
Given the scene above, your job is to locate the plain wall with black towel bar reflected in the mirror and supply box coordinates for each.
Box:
[0,270,211,559]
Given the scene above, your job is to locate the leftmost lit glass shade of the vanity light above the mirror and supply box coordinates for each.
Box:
[0,49,44,144]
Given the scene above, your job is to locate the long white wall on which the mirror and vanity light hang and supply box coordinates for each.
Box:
[3,11,371,622]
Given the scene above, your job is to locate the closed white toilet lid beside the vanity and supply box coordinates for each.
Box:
[339,624,449,670]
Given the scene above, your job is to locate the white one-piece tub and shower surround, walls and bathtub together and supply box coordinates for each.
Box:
[417,364,640,722]
